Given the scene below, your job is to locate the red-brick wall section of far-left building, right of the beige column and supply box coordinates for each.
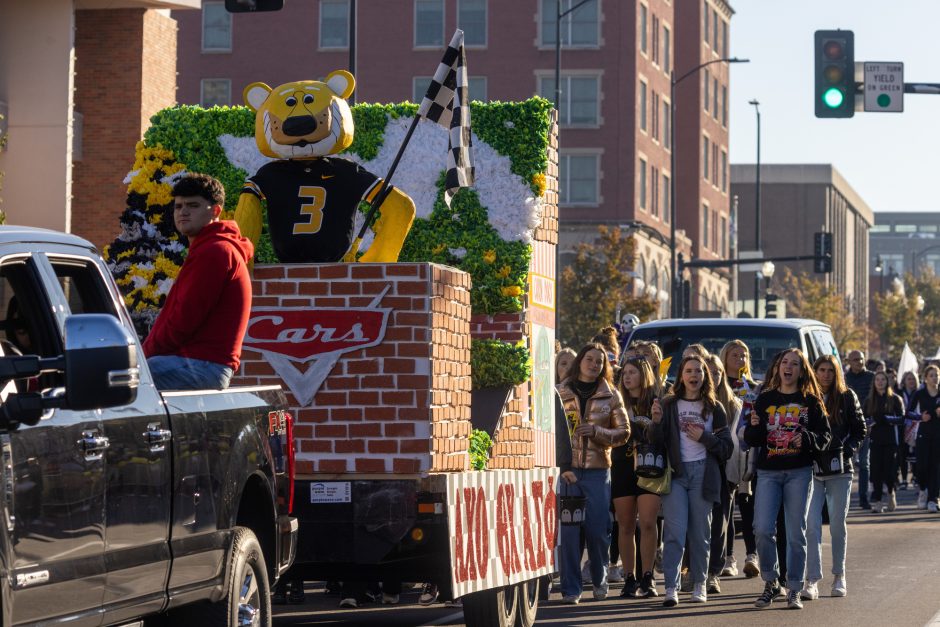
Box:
[72,9,176,248]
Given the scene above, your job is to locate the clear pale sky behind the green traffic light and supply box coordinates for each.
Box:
[728,0,940,211]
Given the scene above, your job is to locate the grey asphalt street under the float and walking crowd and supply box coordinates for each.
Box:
[275,491,940,627]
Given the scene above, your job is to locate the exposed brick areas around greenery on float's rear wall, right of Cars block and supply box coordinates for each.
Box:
[470,114,558,470]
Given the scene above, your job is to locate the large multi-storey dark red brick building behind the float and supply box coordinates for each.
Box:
[173,0,733,315]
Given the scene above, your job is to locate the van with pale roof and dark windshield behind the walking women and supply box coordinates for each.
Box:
[627,318,839,381]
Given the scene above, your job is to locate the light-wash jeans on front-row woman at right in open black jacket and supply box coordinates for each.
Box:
[806,473,852,581]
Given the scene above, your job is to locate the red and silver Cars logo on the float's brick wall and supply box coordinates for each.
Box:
[242,286,392,407]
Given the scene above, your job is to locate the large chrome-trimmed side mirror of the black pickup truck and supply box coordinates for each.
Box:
[65,314,140,410]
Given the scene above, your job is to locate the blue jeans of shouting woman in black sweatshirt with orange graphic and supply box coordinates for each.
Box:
[754,466,813,590]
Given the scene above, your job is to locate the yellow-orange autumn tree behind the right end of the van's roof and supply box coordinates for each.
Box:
[780,268,869,350]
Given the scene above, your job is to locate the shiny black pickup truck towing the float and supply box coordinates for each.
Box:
[0,227,297,627]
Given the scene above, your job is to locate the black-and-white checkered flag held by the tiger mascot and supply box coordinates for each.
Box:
[418,29,473,207]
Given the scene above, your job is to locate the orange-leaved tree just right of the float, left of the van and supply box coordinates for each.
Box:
[558,225,657,347]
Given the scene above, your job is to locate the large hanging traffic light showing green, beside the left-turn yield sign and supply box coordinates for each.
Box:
[813,30,855,118]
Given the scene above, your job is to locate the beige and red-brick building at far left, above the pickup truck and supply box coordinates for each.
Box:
[0,0,192,247]
